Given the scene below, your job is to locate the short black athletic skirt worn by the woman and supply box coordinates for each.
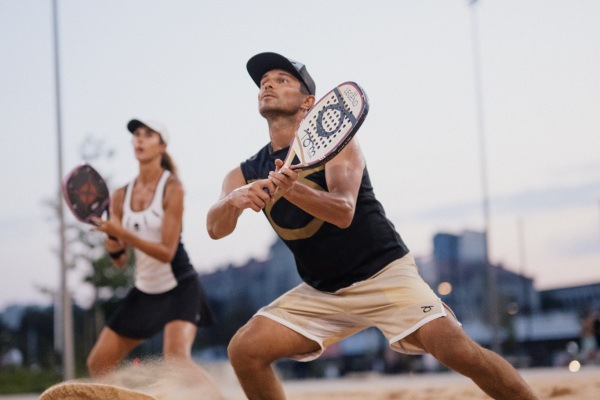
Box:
[107,274,213,339]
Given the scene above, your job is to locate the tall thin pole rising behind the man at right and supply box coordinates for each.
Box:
[469,0,501,353]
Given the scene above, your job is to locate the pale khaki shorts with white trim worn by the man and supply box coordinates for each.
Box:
[256,254,456,361]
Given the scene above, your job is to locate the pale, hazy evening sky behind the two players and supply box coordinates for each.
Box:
[0,0,600,310]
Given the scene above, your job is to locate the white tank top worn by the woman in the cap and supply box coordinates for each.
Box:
[123,170,177,294]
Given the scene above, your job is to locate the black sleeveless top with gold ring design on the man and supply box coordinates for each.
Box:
[241,145,408,292]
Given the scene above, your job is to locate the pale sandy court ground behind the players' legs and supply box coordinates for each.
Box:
[0,364,600,400]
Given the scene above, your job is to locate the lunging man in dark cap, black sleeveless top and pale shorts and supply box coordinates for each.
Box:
[207,53,537,400]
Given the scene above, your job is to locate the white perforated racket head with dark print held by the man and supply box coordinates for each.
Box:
[290,82,369,170]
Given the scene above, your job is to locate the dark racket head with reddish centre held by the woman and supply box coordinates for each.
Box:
[62,164,110,224]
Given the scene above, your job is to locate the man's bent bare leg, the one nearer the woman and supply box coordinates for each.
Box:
[227,316,320,400]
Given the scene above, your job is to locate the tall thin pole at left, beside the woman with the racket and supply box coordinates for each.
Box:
[52,0,75,380]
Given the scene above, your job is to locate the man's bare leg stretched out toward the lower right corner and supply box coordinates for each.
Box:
[407,317,538,400]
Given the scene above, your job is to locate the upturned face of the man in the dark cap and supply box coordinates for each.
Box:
[258,69,305,118]
